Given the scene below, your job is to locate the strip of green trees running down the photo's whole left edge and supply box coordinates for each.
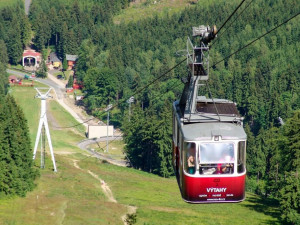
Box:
[0,2,38,197]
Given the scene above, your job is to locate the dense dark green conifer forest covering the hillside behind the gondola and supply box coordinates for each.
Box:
[0,0,300,224]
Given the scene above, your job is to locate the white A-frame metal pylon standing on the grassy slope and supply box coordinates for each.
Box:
[33,88,57,172]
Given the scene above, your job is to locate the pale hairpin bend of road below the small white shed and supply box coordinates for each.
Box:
[77,137,130,167]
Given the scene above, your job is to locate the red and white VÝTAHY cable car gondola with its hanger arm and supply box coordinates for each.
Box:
[173,26,247,203]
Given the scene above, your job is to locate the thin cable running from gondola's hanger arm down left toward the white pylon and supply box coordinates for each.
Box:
[53,58,186,129]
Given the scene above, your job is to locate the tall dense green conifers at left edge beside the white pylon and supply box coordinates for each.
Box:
[0,95,37,196]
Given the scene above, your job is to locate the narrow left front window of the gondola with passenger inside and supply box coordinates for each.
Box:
[183,142,196,175]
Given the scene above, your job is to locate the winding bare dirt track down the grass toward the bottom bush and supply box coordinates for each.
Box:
[73,160,137,225]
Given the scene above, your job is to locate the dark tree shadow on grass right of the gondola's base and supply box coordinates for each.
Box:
[242,196,281,225]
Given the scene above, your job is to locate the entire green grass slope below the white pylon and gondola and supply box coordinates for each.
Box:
[0,83,279,225]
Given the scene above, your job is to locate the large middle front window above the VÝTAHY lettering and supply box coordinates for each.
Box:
[199,143,235,175]
